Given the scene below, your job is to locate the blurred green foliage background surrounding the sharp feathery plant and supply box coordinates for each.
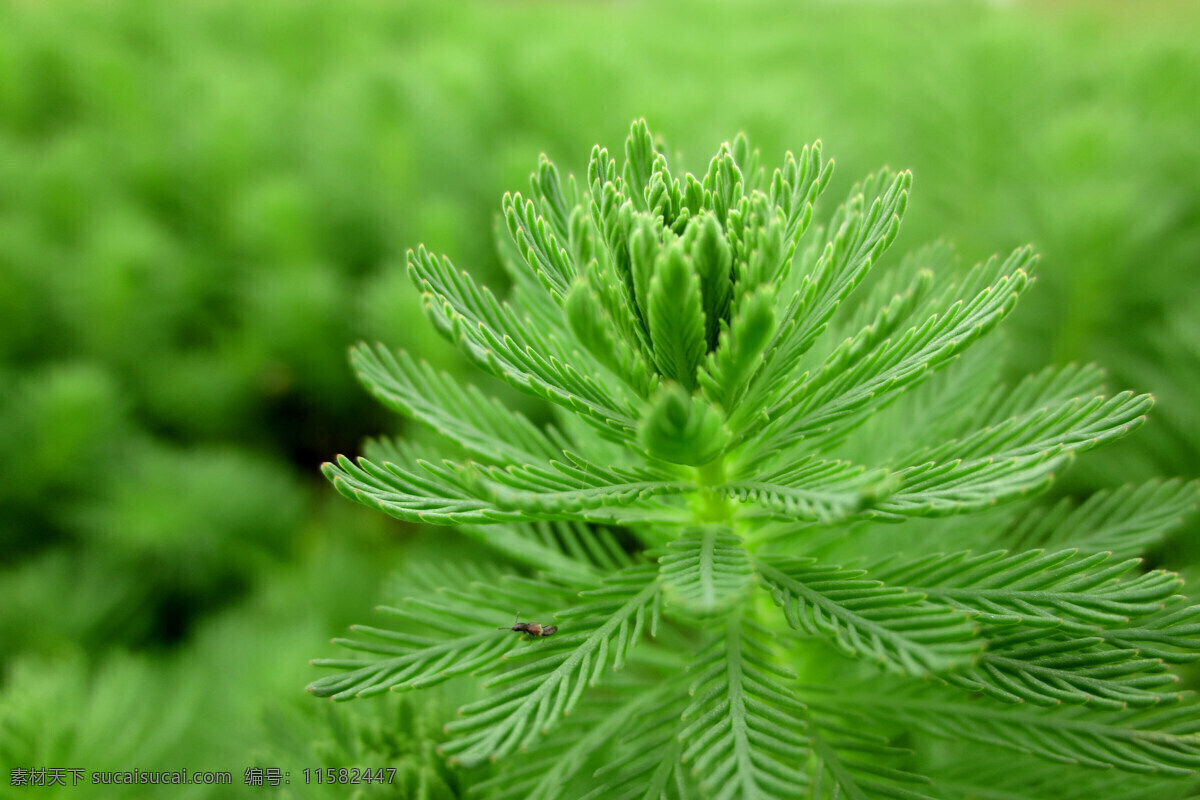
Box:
[0,0,1200,798]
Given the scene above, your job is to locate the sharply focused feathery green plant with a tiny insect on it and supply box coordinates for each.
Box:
[310,122,1200,798]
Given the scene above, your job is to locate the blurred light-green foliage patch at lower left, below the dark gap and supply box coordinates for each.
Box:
[0,532,422,799]
